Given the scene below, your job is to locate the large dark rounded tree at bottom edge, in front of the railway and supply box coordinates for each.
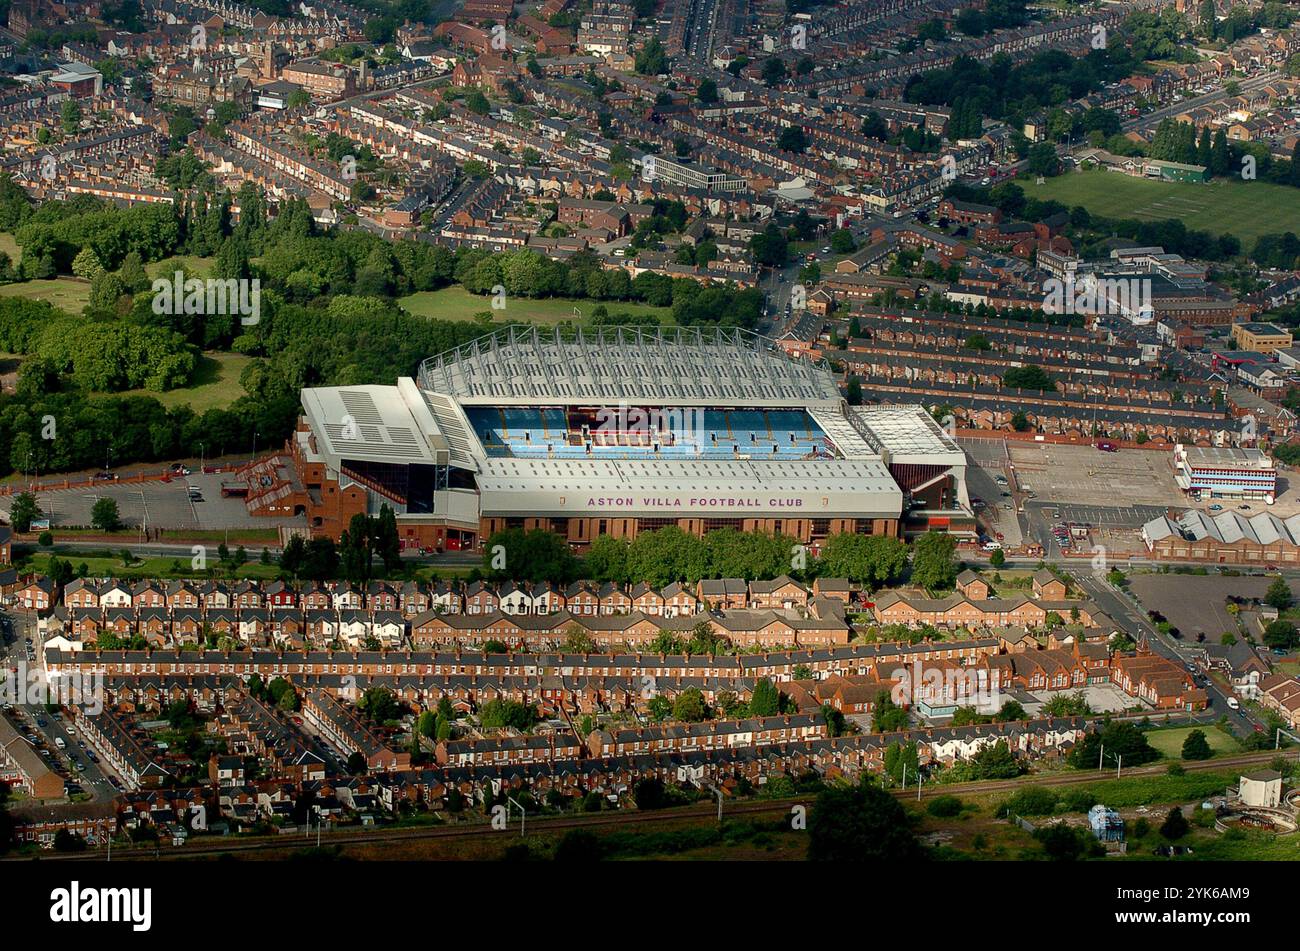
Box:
[807,785,924,861]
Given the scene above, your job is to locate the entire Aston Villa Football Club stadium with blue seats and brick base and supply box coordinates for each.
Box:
[233,326,975,551]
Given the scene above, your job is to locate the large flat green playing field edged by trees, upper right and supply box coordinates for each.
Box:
[1021,171,1300,249]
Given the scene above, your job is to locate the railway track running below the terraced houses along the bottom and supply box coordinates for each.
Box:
[25,750,1277,861]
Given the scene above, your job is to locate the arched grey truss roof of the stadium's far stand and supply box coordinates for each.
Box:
[420,326,840,409]
